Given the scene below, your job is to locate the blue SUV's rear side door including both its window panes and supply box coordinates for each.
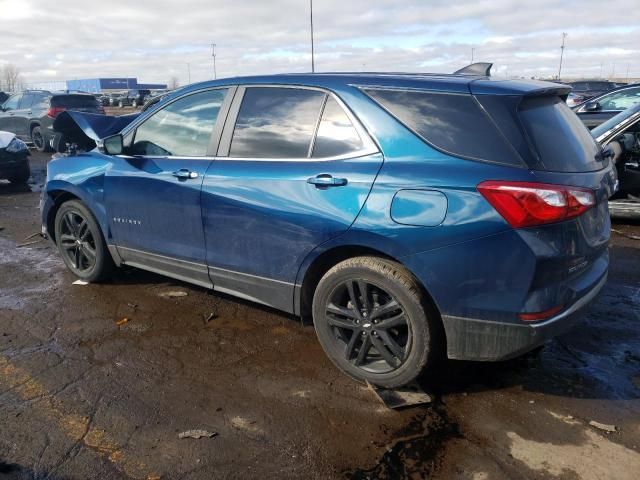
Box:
[202,86,382,311]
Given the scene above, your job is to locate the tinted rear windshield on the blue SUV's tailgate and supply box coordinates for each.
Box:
[519,96,602,172]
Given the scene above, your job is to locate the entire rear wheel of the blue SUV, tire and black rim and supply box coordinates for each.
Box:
[313,257,440,388]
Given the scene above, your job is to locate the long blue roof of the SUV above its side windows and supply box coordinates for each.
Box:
[179,72,570,95]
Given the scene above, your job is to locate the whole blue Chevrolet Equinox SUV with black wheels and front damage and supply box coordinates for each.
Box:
[42,74,617,387]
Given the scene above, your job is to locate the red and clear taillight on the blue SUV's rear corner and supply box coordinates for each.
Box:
[478,180,596,228]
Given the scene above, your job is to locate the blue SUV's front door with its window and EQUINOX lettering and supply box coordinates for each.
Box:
[105,89,228,286]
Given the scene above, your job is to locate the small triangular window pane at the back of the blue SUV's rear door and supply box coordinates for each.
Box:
[312,97,362,158]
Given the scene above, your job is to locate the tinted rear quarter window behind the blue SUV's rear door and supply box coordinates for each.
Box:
[365,89,524,166]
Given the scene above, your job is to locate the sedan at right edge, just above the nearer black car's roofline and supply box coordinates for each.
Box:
[567,84,640,129]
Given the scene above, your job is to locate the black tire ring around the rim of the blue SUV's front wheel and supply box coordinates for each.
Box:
[55,200,110,282]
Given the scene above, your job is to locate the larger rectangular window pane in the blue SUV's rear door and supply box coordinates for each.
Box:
[229,87,325,158]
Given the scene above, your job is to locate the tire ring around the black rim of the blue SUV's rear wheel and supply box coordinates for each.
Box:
[313,260,432,388]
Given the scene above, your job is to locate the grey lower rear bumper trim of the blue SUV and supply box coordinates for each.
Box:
[442,273,607,361]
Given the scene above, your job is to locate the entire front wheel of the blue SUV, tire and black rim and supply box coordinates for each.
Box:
[55,200,115,282]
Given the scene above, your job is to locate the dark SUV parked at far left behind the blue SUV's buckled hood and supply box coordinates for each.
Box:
[0,90,104,152]
